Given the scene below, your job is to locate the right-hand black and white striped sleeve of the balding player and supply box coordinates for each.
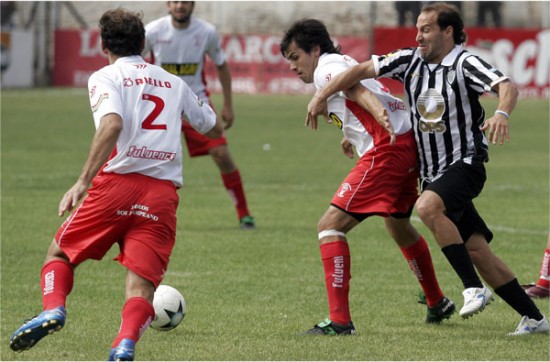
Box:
[462,55,508,93]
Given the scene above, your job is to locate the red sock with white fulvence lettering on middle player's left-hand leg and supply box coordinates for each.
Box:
[320,241,351,324]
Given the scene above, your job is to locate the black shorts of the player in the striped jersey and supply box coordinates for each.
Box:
[421,161,493,242]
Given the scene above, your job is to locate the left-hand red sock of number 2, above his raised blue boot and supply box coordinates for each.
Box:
[40,259,74,310]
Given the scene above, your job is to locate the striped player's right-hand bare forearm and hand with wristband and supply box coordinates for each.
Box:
[481,80,519,145]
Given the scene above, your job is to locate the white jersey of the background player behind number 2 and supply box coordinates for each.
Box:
[143,15,226,100]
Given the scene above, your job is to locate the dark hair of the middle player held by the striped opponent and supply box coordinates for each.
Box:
[279,19,341,56]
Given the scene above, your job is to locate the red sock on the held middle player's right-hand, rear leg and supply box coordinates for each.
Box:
[401,236,443,307]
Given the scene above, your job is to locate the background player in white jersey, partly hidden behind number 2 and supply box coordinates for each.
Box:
[143,1,255,229]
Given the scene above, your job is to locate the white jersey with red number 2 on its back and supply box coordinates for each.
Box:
[88,55,216,187]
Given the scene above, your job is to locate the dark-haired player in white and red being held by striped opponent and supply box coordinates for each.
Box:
[280,19,455,335]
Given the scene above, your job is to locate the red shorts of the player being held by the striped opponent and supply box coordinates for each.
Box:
[331,132,418,218]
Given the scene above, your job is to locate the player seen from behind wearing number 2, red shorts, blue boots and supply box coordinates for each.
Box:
[10,9,223,361]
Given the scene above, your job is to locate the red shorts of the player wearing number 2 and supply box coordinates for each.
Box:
[55,173,179,287]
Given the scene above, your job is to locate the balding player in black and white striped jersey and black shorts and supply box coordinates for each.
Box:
[306,3,549,335]
